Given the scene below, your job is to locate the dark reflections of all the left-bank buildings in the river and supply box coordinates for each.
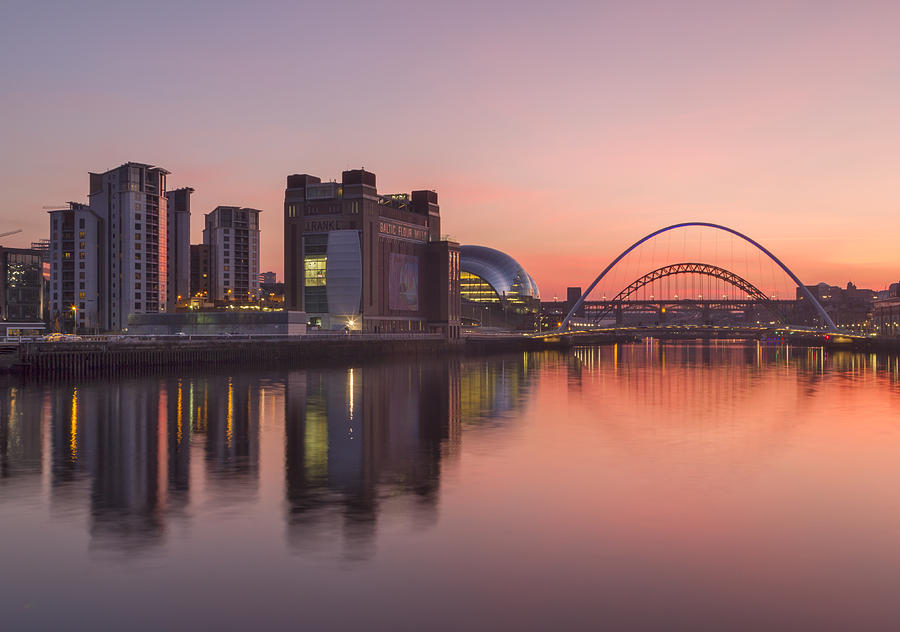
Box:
[0,355,536,558]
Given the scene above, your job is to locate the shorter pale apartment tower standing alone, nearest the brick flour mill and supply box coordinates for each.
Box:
[203,206,260,303]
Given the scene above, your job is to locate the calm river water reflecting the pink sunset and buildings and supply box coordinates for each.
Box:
[0,343,900,630]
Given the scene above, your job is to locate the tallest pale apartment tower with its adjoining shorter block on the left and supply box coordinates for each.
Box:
[50,162,169,331]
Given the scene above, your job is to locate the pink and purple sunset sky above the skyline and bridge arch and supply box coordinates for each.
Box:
[0,0,900,298]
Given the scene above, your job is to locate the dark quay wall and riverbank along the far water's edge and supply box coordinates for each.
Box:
[7,332,900,379]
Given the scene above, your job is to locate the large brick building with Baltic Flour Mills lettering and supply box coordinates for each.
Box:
[284,169,460,338]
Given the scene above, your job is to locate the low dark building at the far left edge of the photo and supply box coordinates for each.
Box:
[0,246,44,322]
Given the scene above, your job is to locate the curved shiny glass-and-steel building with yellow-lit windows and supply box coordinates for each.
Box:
[459,246,541,329]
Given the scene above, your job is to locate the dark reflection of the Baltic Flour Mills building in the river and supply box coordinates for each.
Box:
[285,363,460,557]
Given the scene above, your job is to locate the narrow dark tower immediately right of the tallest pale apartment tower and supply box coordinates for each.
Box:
[166,187,194,311]
